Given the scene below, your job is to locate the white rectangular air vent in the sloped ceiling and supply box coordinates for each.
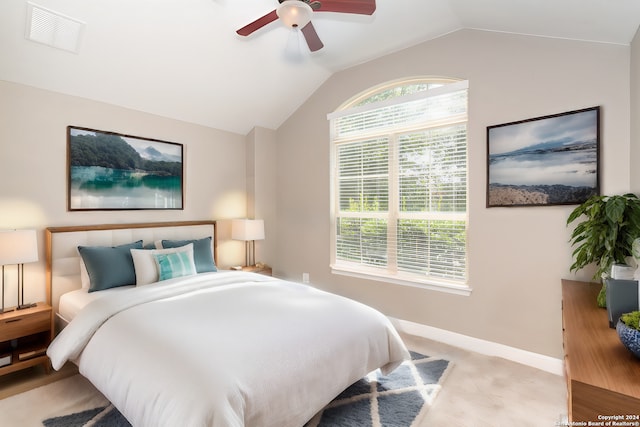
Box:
[25,3,85,53]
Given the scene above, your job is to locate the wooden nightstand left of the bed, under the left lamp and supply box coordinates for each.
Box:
[0,302,51,375]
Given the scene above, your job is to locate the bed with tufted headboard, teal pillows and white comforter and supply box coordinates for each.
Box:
[45,221,409,427]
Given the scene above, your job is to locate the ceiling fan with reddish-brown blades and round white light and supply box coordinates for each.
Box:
[236,0,376,52]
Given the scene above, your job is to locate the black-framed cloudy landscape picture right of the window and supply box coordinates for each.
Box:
[487,107,600,207]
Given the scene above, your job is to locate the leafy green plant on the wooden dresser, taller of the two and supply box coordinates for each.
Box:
[567,193,640,307]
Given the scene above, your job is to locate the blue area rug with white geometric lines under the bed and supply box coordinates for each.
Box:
[42,352,452,427]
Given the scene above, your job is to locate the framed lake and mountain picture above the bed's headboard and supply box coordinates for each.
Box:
[67,126,184,211]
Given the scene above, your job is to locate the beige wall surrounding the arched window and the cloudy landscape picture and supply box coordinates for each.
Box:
[277,30,630,357]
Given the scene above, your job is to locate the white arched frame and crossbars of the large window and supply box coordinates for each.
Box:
[327,77,471,295]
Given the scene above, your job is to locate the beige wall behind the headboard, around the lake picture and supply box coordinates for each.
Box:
[0,81,247,305]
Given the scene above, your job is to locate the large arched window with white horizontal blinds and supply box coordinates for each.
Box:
[329,80,468,291]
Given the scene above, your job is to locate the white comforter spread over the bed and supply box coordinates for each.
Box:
[47,272,408,427]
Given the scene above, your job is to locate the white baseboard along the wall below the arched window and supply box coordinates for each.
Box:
[391,318,564,375]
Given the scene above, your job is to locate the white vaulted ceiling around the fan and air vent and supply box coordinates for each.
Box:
[0,0,640,135]
